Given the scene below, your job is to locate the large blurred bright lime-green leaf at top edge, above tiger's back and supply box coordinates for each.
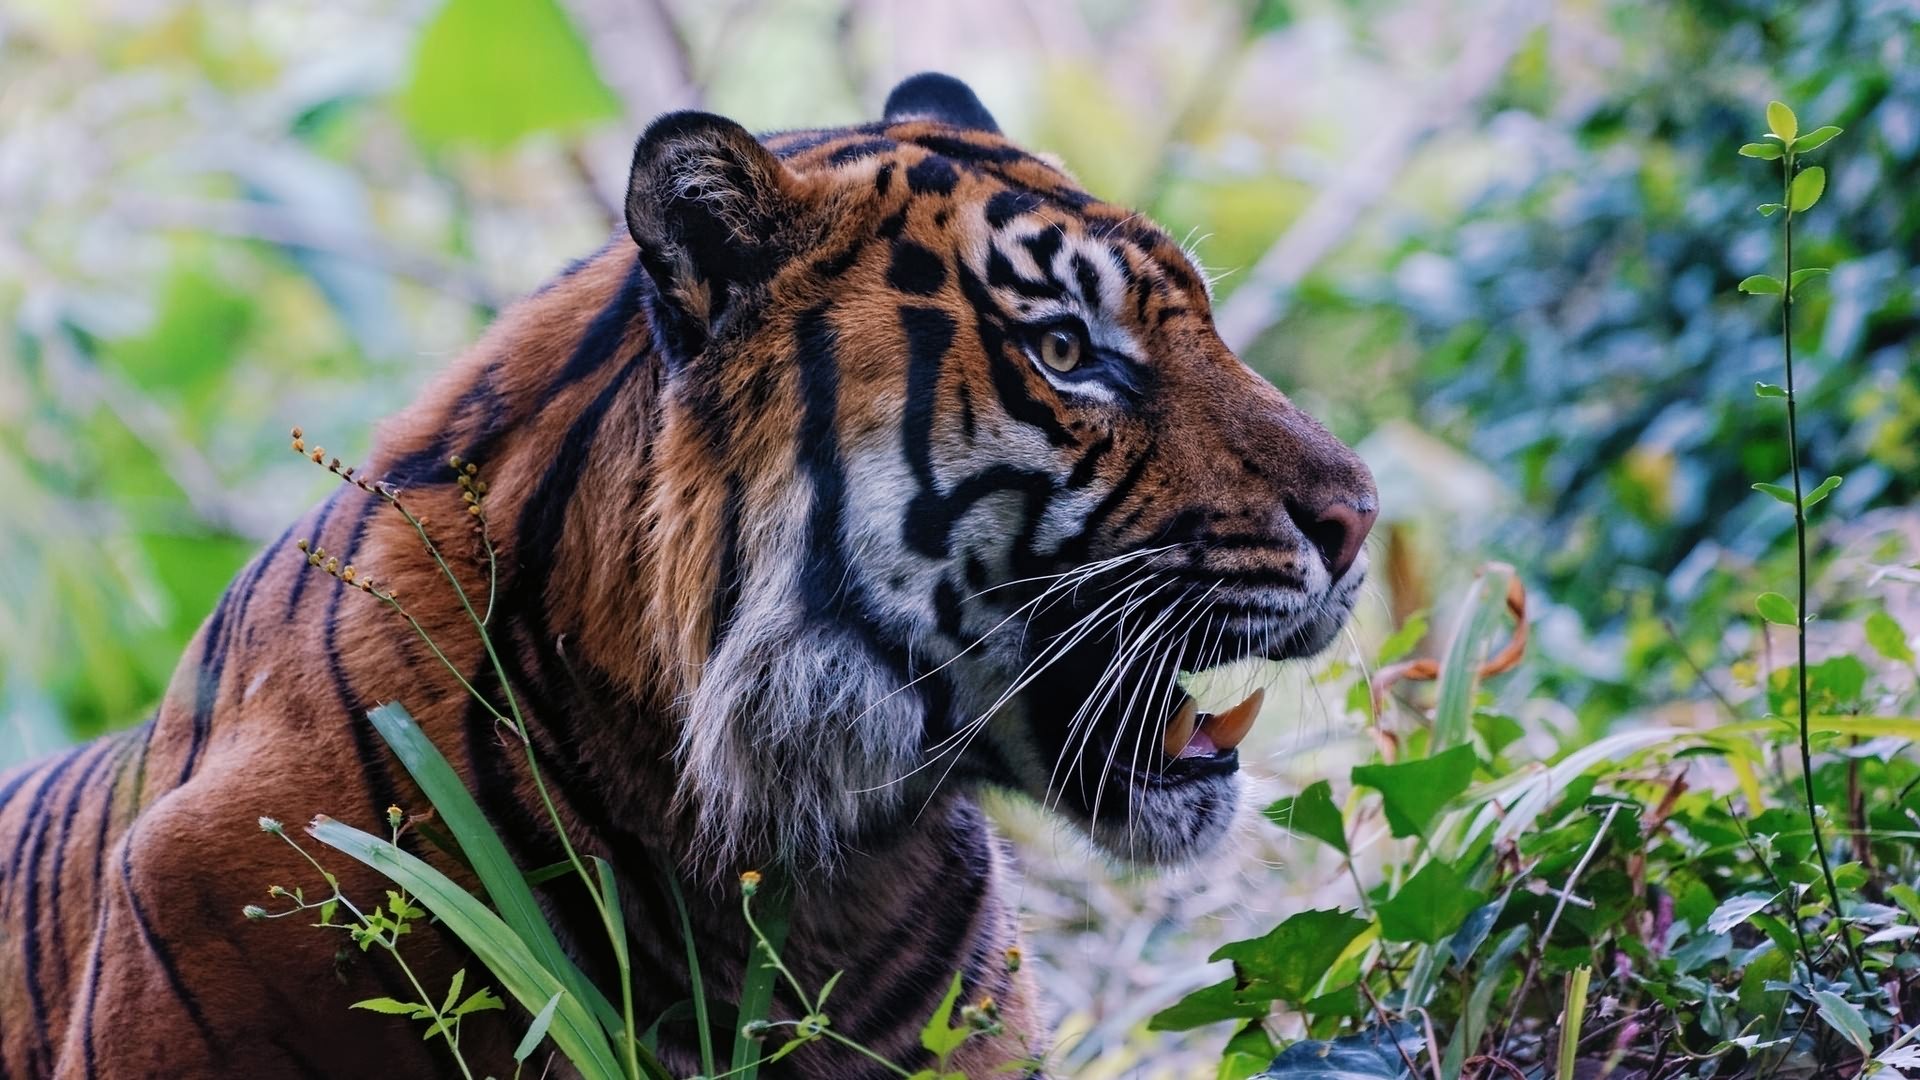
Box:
[399,0,620,150]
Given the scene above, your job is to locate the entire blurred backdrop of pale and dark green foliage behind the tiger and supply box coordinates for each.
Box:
[0,0,1920,757]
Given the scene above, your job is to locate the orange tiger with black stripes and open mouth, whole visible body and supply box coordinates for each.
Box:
[0,73,1379,1078]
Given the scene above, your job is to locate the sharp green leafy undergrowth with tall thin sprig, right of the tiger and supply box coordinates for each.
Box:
[1152,102,1920,1080]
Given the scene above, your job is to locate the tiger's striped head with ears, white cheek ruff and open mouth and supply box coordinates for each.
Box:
[626,75,1377,865]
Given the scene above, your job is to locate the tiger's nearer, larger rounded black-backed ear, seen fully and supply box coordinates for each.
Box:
[626,111,797,359]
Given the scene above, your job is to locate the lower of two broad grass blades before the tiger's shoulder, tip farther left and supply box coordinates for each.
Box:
[307,817,633,1080]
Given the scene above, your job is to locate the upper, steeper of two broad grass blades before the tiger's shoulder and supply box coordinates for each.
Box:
[367,701,626,1040]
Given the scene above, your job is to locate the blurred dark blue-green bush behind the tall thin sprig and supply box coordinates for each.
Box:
[1351,0,1920,630]
